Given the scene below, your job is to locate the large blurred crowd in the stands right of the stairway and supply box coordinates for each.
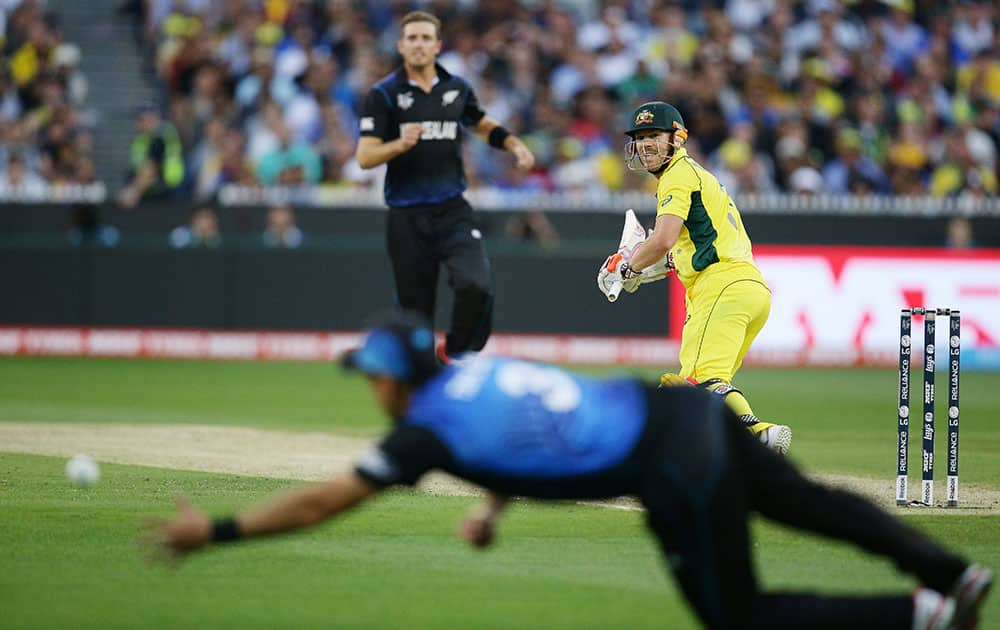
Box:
[123,0,1000,199]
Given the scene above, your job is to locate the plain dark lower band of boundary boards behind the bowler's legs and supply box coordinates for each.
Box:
[0,241,668,335]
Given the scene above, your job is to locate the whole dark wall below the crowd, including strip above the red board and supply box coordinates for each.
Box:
[0,204,1000,335]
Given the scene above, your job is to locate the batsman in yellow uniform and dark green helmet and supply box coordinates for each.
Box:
[598,101,792,453]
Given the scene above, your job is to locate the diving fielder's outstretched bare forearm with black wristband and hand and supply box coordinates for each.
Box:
[140,473,380,561]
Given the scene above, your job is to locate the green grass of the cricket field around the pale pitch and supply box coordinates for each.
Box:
[0,359,1000,628]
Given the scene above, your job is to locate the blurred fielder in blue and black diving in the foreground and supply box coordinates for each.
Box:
[145,311,993,630]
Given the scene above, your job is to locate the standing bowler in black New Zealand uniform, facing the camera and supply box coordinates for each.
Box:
[356,11,535,362]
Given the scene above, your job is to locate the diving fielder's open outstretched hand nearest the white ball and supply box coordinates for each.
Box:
[138,496,212,565]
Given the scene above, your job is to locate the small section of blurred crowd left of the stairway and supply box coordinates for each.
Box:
[0,0,95,197]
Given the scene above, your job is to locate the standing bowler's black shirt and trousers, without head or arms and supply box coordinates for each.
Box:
[360,65,493,355]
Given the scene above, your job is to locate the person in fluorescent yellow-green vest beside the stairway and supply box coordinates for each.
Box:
[118,103,184,208]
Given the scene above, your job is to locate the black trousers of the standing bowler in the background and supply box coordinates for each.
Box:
[386,196,493,356]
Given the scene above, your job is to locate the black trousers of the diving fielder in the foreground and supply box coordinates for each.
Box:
[640,388,966,630]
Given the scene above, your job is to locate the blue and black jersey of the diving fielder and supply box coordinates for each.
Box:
[357,357,647,498]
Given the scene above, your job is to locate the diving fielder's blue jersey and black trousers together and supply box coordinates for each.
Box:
[356,357,966,630]
